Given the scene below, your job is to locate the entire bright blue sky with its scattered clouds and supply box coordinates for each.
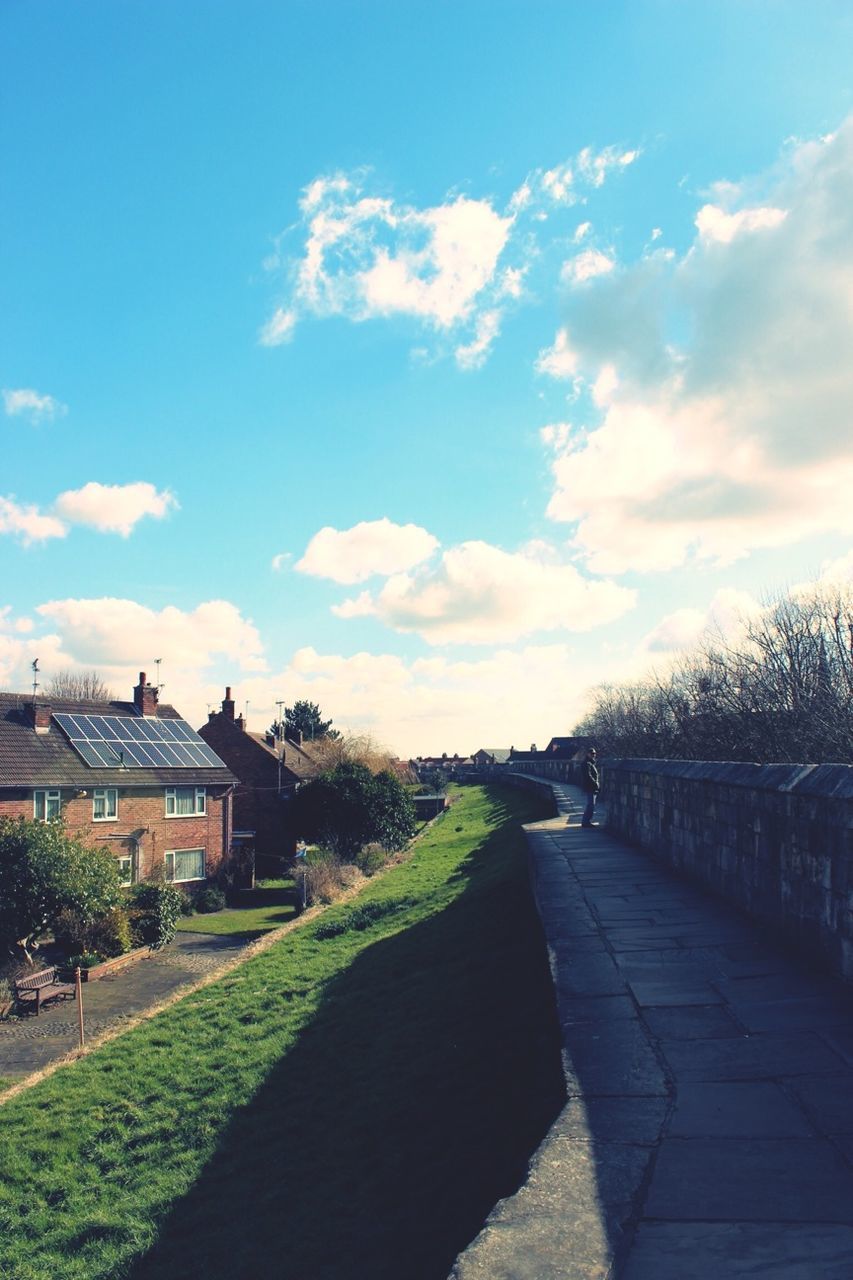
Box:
[0,0,853,756]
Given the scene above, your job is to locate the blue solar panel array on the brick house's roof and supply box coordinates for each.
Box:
[54,713,225,769]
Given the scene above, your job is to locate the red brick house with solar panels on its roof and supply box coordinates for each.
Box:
[0,672,237,892]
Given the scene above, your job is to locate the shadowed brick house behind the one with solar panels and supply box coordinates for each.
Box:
[199,687,323,874]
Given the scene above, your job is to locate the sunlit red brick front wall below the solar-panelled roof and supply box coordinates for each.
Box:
[0,787,232,879]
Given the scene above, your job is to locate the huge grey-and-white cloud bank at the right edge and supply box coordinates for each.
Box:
[545,119,853,573]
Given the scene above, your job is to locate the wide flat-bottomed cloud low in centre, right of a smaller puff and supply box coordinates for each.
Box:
[334,541,635,644]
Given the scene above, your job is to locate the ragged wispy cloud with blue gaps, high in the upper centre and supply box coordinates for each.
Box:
[259,147,638,370]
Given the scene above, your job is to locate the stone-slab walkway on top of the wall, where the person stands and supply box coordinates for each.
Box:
[453,787,853,1280]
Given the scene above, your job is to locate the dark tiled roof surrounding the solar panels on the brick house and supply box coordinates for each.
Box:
[0,692,237,788]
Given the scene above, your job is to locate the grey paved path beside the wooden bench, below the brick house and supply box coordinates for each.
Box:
[0,933,246,1078]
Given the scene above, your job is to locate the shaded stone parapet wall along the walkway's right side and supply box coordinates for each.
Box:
[602,759,853,980]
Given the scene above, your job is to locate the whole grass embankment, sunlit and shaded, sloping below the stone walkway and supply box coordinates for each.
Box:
[0,787,562,1280]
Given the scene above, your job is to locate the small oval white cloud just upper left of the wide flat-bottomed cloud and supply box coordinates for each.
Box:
[295,516,438,585]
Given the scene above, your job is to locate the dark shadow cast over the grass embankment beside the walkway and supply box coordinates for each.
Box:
[129,805,564,1280]
